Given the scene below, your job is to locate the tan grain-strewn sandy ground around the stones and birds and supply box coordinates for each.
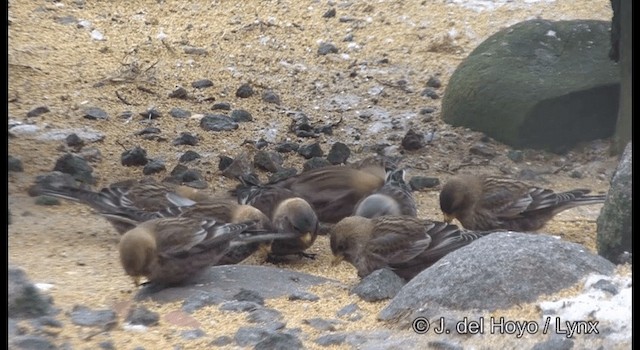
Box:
[8,0,617,349]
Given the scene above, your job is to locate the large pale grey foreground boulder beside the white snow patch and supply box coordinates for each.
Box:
[378,232,615,324]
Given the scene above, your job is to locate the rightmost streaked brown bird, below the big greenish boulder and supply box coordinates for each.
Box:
[439,174,606,232]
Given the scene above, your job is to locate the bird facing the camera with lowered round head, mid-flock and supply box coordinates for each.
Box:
[270,197,319,260]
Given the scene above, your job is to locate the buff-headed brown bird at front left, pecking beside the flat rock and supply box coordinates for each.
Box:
[118,217,300,286]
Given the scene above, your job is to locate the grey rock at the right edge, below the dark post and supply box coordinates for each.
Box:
[597,142,632,263]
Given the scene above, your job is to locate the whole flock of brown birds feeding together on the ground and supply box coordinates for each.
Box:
[35,158,605,286]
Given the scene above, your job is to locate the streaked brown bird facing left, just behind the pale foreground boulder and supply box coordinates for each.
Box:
[329,215,494,281]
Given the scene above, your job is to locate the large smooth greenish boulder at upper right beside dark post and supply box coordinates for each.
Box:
[442,20,620,152]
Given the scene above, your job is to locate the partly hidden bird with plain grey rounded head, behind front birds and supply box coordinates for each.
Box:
[353,169,418,218]
